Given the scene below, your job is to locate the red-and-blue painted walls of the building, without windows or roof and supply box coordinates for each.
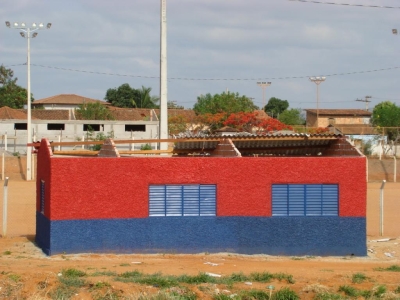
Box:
[36,140,366,255]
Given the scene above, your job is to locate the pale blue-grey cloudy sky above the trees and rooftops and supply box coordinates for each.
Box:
[0,0,400,110]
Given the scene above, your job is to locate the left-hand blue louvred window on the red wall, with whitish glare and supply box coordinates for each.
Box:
[149,184,216,217]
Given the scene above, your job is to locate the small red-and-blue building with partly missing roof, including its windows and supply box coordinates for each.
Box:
[36,134,367,256]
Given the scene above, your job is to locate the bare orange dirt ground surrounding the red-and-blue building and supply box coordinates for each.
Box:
[0,171,400,299]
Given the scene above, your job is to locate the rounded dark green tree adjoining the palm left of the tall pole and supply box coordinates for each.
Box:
[104,83,141,107]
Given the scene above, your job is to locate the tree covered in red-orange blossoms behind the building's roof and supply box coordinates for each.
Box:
[223,112,292,133]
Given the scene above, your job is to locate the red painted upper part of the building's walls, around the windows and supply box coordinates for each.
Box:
[38,141,366,220]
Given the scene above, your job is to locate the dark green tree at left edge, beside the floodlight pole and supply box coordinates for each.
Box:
[0,65,34,108]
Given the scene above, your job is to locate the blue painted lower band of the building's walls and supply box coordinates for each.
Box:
[36,213,367,256]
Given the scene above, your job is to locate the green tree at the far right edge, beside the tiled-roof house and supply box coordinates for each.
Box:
[371,101,400,140]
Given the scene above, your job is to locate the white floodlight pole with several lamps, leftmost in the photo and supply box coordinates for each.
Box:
[6,21,51,180]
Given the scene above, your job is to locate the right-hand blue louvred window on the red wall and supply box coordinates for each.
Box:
[272,184,339,216]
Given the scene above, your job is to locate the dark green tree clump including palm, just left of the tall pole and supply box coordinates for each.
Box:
[104,83,159,108]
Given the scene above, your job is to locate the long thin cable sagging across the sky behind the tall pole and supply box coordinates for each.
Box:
[7,64,400,81]
